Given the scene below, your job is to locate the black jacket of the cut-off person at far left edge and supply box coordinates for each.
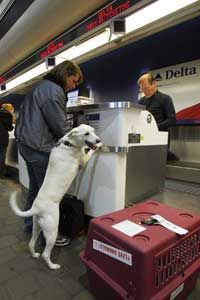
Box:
[0,109,13,146]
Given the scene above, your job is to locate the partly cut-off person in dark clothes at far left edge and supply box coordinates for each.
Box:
[0,103,14,179]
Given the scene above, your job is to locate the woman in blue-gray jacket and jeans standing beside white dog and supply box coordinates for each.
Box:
[15,61,83,246]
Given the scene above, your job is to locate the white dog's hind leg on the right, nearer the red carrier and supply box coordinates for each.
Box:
[42,230,60,270]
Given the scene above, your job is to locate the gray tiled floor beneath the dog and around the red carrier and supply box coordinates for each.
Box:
[0,179,200,300]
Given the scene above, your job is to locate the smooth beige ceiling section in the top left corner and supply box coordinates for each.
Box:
[0,0,108,74]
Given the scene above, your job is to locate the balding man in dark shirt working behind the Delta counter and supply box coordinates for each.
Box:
[137,72,178,160]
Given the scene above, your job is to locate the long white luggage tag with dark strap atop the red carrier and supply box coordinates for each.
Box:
[141,215,188,235]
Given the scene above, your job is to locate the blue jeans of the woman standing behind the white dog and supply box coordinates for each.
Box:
[18,143,49,232]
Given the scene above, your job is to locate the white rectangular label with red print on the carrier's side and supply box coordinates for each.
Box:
[93,240,132,266]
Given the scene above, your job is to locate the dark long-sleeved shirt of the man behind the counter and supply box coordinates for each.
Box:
[139,91,176,131]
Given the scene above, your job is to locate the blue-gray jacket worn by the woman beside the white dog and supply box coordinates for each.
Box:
[15,79,67,152]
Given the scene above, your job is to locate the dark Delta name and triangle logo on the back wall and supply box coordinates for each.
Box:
[155,67,197,81]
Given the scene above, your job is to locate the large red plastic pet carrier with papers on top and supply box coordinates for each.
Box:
[80,200,200,300]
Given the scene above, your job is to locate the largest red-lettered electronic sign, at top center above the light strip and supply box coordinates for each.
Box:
[86,1,131,31]
